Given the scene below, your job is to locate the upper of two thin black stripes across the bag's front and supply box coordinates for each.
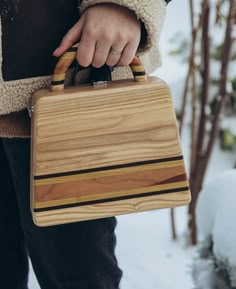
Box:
[34,156,183,180]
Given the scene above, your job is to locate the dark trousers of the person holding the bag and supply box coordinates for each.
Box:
[0,138,122,289]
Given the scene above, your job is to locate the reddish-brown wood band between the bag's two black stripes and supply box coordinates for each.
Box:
[35,162,187,207]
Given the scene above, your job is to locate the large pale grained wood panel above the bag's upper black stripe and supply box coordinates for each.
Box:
[31,79,181,175]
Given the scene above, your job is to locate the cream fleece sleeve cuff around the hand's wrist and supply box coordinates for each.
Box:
[80,0,166,54]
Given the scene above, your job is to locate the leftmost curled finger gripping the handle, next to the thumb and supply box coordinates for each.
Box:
[76,35,96,67]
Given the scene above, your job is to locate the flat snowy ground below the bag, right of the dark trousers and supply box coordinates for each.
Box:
[117,208,194,289]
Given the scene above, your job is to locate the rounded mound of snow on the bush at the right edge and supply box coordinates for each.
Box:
[196,169,236,286]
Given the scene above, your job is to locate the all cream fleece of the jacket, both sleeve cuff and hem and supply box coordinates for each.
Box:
[0,0,166,136]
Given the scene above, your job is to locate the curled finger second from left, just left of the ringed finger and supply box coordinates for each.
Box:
[92,40,112,68]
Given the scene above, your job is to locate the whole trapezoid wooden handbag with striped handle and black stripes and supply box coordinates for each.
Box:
[31,49,190,226]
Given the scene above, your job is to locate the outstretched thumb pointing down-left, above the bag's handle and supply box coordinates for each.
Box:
[53,18,84,57]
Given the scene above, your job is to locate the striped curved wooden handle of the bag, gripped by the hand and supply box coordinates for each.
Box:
[51,44,147,91]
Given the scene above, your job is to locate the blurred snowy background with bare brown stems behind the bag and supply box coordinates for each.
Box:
[30,0,236,289]
